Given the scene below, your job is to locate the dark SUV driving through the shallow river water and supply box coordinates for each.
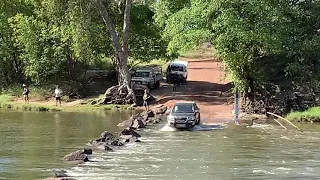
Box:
[167,102,200,129]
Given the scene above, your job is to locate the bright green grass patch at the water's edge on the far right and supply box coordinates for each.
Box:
[286,107,320,122]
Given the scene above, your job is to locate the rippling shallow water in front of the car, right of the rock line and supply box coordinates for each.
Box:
[68,122,320,180]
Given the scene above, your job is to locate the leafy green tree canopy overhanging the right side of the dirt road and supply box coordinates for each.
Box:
[155,0,320,100]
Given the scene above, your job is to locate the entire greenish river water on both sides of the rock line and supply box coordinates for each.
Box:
[0,111,320,180]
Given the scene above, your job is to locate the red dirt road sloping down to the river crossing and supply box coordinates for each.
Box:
[151,60,233,123]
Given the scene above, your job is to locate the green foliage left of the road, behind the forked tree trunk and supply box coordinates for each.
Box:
[0,0,166,88]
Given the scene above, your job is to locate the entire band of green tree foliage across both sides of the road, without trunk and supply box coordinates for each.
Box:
[0,0,320,111]
